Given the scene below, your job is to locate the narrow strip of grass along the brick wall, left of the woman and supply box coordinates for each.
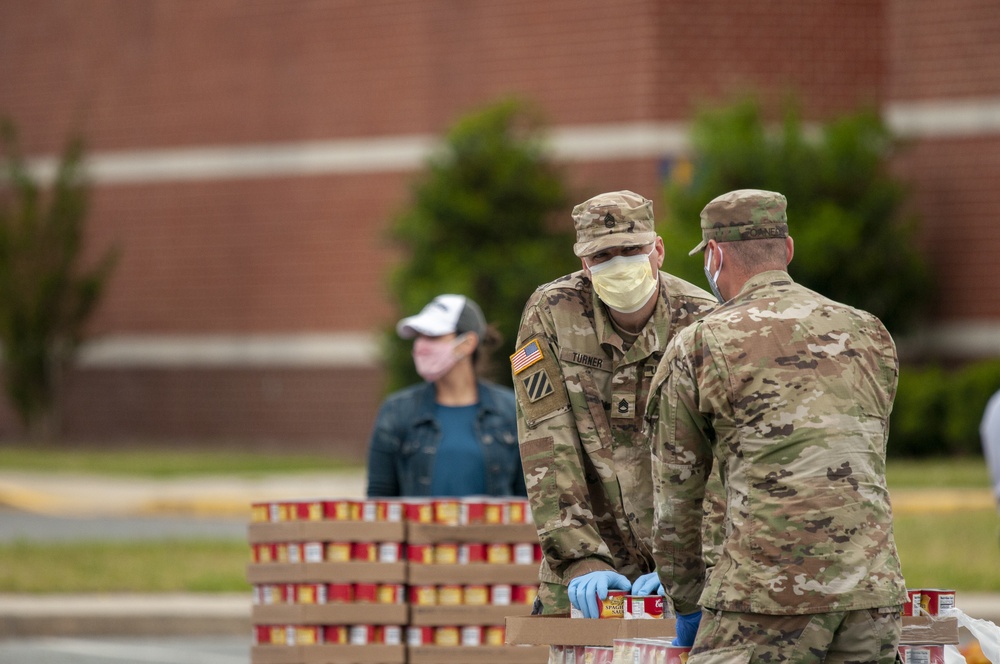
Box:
[0,445,363,477]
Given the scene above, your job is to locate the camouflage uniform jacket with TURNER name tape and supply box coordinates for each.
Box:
[511,271,716,584]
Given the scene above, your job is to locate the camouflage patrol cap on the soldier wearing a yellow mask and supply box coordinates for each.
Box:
[573,190,656,256]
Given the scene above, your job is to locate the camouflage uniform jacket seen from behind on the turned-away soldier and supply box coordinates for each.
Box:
[649,271,906,615]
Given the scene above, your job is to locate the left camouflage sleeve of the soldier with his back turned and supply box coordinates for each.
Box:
[650,334,712,614]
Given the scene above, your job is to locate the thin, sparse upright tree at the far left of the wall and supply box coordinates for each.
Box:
[0,121,116,438]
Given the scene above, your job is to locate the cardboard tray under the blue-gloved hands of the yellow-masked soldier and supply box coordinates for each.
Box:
[505,615,677,646]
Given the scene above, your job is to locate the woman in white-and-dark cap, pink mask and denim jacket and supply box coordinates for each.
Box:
[367,295,525,497]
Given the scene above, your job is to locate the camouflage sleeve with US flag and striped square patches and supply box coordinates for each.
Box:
[512,293,614,583]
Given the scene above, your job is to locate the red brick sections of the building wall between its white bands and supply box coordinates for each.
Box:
[0,0,1000,447]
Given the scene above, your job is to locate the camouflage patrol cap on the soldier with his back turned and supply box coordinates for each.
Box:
[688,189,788,256]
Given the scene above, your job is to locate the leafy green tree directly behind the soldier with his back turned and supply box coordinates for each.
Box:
[663,100,930,332]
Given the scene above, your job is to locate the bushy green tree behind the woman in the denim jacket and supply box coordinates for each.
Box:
[386,100,579,389]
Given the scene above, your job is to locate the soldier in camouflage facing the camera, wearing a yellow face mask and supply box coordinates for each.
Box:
[511,191,721,614]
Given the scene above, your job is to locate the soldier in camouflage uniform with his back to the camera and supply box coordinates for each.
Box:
[647,190,906,664]
